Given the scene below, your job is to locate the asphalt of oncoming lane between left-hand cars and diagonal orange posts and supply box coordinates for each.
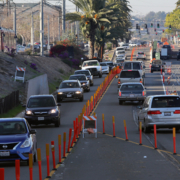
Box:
[0,75,106,180]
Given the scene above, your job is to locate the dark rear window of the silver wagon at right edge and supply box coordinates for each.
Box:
[151,97,180,108]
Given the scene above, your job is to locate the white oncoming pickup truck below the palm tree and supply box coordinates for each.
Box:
[80,59,102,78]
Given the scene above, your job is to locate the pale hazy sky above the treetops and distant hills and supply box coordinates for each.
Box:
[14,0,178,15]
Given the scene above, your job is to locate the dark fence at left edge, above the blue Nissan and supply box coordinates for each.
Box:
[0,91,19,114]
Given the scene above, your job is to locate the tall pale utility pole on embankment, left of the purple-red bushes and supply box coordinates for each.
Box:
[40,0,44,56]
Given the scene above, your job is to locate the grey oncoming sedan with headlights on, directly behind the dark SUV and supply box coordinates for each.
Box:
[57,80,84,102]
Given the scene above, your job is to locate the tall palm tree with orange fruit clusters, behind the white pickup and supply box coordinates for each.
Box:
[66,0,118,58]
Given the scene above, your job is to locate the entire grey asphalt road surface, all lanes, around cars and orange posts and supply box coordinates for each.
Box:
[0,48,180,180]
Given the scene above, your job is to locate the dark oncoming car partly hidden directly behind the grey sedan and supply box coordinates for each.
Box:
[69,74,90,92]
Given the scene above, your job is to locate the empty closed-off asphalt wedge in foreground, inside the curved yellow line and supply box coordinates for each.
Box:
[51,134,179,180]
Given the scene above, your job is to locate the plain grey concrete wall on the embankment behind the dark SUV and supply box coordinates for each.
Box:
[26,74,49,102]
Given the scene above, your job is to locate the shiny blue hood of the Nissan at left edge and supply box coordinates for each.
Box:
[0,134,28,144]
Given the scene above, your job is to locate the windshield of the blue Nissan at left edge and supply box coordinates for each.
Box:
[0,121,27,135]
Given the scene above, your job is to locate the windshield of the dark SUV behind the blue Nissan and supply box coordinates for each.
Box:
[27,97,56,108]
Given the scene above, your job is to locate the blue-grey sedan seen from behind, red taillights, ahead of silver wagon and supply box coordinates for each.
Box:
[118,82,146,105]
